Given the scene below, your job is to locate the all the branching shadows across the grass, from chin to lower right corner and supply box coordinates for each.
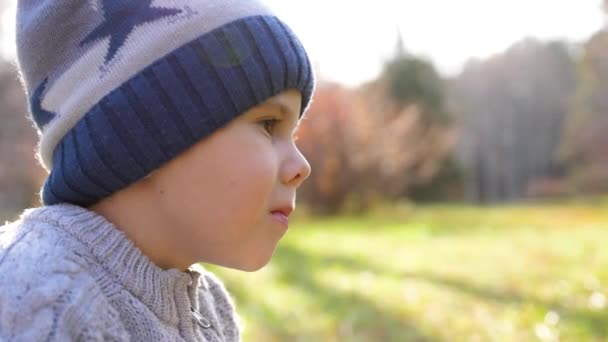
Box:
[218,239,608,341]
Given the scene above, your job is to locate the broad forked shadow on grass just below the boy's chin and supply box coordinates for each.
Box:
[231,245,440,342]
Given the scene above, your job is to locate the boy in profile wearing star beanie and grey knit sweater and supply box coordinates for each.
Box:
[0,0,314,341]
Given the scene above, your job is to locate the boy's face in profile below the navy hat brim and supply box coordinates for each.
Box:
[135,90,311,271]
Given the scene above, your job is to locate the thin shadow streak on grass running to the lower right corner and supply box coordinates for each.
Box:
[402,272,608,341]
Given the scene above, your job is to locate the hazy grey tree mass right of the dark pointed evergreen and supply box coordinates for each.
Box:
[450,39,575,202]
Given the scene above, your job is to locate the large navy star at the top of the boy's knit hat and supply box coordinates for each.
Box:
[80,0,182,63]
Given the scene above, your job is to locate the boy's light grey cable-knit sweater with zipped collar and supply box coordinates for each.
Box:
[0,204,240,342]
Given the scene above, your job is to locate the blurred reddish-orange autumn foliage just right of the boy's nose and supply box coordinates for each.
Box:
[299,76,455,213]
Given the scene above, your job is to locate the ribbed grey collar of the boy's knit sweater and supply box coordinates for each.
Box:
[21,203,208,326]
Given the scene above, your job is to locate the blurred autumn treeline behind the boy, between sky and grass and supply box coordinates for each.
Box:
[0,11,608,214]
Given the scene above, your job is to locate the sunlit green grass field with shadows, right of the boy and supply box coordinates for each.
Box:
[207,202,608,342]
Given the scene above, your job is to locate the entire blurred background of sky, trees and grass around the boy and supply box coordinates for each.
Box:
[0,0,608,341]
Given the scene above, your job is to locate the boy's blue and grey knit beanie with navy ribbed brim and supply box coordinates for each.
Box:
[17,0,314,207]
